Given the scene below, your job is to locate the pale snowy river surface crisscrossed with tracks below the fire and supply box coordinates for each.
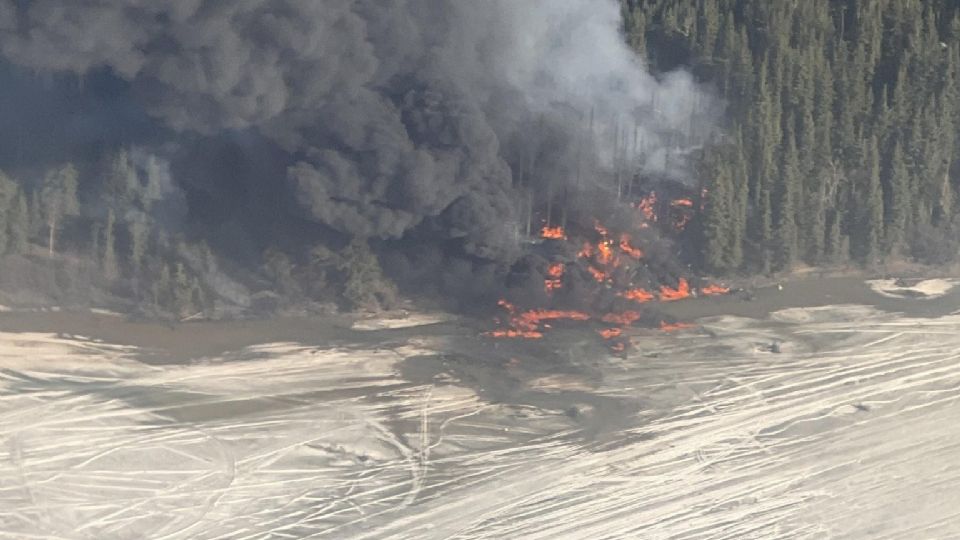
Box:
[0,306,960,539]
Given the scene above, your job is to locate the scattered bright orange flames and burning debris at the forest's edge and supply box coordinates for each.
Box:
[487,182,730,353]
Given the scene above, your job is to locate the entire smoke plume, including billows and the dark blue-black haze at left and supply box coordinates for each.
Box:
[0,0,716,310]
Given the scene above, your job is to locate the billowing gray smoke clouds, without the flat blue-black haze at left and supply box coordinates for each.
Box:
[0,0,711,260]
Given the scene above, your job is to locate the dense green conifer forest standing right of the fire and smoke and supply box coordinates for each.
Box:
[623,0,960,272]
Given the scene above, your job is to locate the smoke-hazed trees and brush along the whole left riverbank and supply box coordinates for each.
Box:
[0,149,397,318]
